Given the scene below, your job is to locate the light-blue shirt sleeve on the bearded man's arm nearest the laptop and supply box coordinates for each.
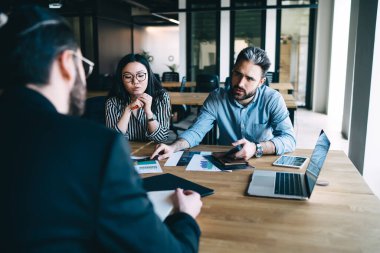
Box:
[269,93,296,155]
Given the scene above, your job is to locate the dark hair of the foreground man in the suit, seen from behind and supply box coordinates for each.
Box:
[0,5,78,87]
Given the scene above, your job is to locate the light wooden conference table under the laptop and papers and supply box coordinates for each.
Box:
[131,142,380,253]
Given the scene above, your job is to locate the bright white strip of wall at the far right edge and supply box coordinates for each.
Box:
[363,0,380,198]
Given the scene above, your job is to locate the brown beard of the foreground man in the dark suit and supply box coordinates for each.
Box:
[69,66,86,116]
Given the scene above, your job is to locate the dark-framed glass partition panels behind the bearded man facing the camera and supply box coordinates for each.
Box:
[186,0,318,108]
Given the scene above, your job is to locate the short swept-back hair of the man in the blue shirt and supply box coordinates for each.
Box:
[234,47,271,77]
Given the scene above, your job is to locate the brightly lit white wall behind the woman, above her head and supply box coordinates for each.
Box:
[134,26,182,78]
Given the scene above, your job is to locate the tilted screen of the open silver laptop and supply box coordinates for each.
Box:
[305,130,330,198]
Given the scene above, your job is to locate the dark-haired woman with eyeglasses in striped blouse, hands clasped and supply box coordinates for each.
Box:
[106,54,171,142]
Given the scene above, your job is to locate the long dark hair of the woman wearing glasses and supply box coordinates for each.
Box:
[108,54,164,102]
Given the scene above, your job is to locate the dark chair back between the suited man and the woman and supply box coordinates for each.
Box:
[82,96,106,125]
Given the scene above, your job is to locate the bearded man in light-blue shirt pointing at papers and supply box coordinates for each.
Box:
[152,47,296,160]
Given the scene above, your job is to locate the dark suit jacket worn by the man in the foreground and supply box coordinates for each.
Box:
[0,88,200,252]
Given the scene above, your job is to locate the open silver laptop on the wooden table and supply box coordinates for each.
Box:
[248,130,330,199]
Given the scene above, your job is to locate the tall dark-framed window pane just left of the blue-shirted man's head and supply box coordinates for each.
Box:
[187,0,220,80]
